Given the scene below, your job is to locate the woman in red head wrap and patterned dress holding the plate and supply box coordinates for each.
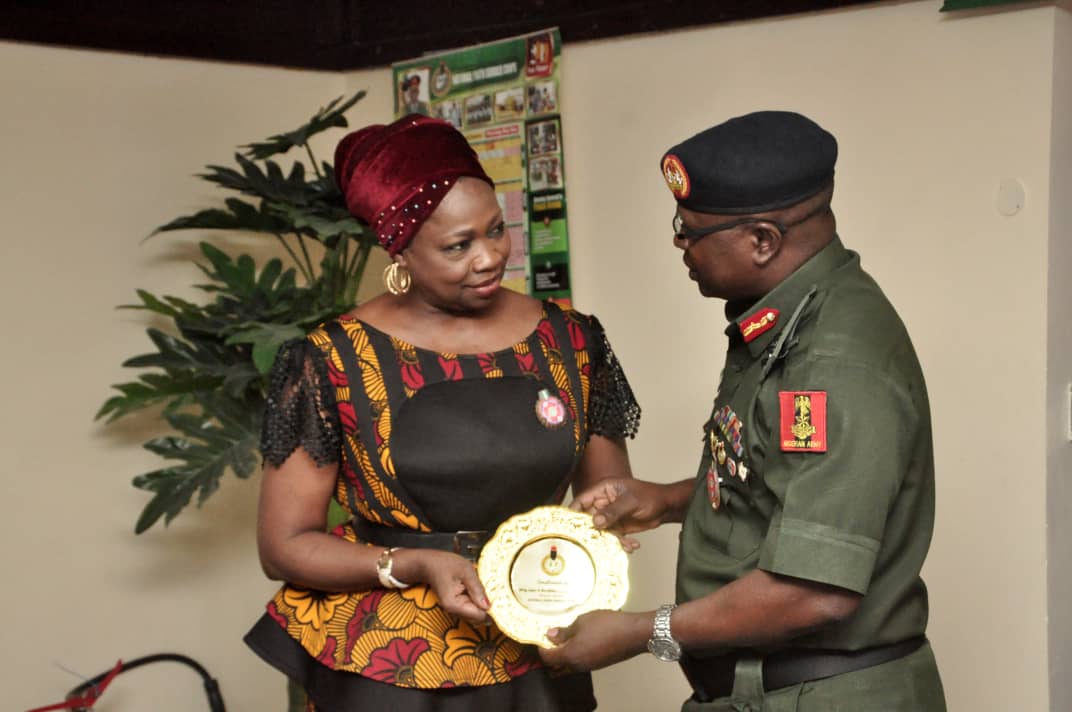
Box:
[247,116,640,712]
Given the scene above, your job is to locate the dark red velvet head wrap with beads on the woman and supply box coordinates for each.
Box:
[334,114,495,255]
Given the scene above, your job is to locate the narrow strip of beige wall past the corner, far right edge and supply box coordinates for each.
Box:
[1046,4,1072,710]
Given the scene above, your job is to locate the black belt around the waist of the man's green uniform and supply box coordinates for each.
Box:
[680,636,926,702]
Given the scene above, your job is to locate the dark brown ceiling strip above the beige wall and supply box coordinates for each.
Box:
[0,0,874,70]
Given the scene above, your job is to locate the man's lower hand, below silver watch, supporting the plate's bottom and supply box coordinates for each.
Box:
[539,610,652,671]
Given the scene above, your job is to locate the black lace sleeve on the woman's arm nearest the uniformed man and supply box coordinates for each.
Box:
[589,316,640,437]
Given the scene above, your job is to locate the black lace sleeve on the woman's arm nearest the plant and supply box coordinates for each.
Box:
[260,339,342,468]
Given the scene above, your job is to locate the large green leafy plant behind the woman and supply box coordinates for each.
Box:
[96,91,376,533]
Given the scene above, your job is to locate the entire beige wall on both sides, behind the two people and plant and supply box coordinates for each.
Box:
[0,0,1072,712]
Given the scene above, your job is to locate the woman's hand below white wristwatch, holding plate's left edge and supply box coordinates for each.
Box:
[393,549,491,623]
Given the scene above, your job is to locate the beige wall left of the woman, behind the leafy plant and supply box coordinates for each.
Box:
[0,44,389,712]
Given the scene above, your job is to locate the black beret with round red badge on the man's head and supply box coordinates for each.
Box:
[660,112,837,214]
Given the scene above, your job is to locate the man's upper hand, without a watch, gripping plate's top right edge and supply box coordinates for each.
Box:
[569,477,674,534]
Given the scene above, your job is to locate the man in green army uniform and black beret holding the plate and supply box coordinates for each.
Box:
[542,112,946,712]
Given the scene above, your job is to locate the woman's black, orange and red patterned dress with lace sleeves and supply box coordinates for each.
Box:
[245,302,640,712]
